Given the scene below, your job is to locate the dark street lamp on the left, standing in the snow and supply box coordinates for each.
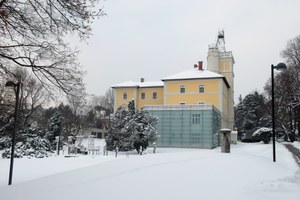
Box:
[5,81,20,185]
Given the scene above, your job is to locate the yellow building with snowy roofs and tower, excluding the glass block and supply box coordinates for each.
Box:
[113,42,234,129]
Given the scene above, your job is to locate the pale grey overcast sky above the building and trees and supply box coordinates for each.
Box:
[77,0,300,102]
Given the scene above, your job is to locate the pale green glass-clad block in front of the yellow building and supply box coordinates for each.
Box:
[144,105,221,149]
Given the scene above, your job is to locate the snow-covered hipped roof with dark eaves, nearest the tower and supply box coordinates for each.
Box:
[162,68,230,87]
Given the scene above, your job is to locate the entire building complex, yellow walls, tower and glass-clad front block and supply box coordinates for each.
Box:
[112,32,234,148]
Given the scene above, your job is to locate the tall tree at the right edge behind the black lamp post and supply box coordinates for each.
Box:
[264,35,300,141]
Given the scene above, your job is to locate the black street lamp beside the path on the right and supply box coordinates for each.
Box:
[271,63,286,162]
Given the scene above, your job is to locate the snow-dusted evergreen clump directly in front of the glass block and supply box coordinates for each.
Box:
[106,101,158,153]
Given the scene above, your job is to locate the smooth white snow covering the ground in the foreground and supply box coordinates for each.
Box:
[0,143,300,200]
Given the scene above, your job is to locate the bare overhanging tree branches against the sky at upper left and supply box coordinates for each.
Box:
[0,0,104,94]
